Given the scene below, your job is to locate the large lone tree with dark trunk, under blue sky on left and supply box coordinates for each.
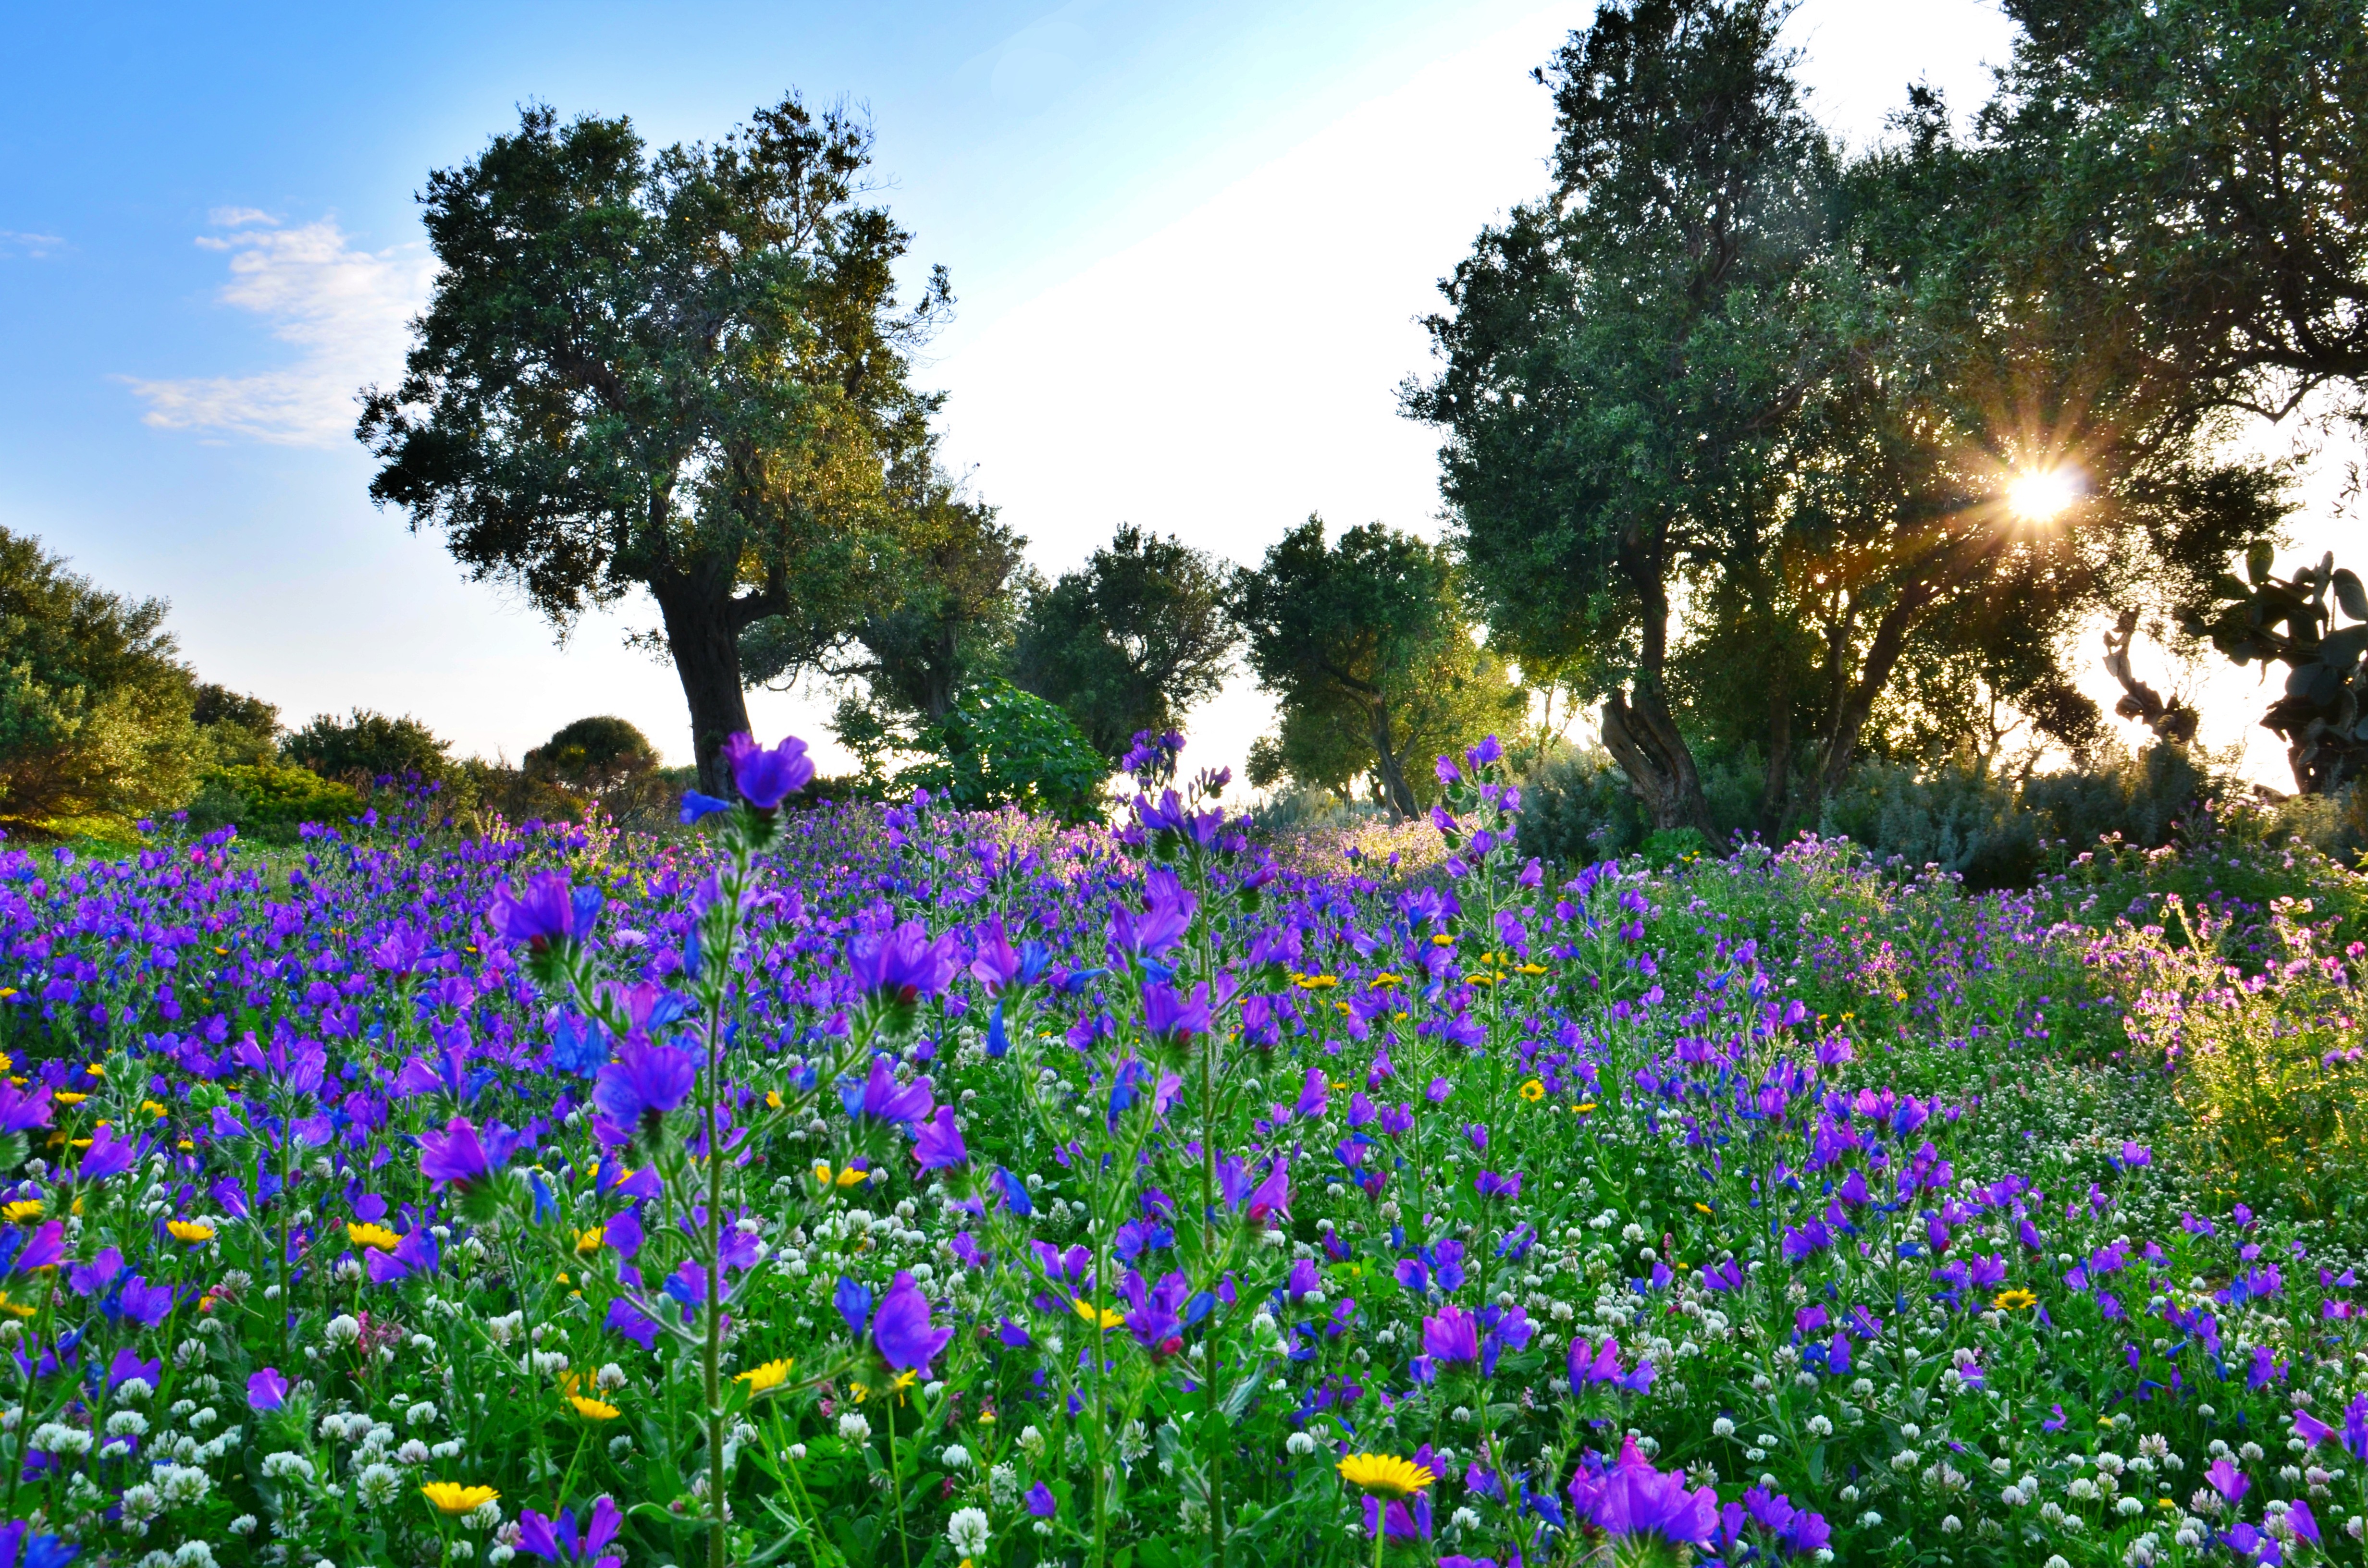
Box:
[358,95,950,794]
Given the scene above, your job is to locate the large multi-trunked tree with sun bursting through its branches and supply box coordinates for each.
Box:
[1406,0,2281,836]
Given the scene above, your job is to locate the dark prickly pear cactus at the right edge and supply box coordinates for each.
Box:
[2188,551,2368,796]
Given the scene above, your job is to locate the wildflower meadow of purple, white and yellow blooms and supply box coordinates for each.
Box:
[0,741,2368,1568]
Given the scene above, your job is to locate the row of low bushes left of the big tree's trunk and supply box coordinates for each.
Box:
[0,530,684,841]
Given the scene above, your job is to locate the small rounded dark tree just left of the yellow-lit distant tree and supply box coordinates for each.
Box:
[1011,524,1241,763]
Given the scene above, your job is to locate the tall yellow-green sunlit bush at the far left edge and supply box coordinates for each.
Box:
[0,530,197,829]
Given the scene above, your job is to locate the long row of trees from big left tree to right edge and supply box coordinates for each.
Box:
[358,0,2368,838]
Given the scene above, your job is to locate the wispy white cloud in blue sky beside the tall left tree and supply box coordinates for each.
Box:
[125,208,436,445]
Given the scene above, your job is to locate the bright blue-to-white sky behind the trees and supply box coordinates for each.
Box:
[0,0,2356,800]
